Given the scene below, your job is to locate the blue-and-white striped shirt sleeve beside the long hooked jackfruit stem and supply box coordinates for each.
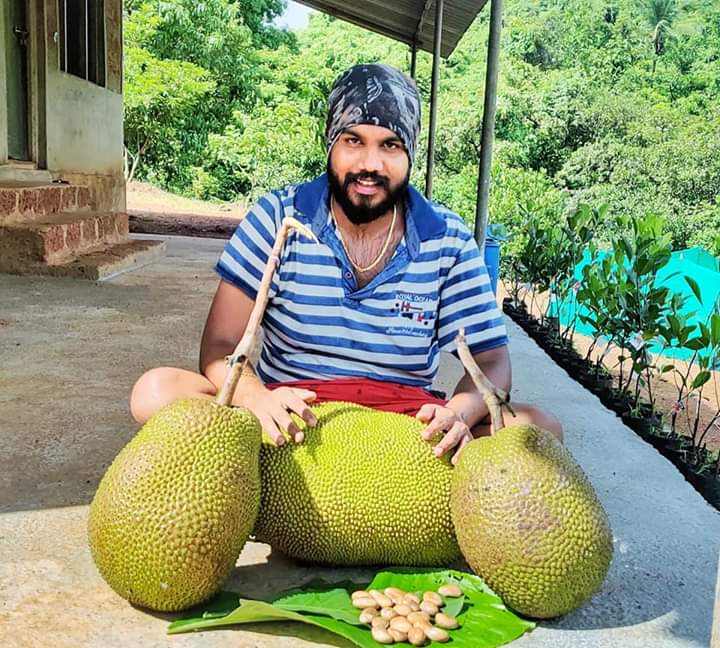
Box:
[215,193,282,299]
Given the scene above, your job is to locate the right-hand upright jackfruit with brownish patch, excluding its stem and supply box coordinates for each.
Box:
[450,425,613,619]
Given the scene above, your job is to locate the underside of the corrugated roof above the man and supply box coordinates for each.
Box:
[298,0,488,57]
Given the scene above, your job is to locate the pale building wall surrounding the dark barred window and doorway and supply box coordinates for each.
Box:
[0,0,126,211]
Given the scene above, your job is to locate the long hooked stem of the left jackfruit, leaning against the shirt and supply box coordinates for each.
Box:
[215,216,318,406]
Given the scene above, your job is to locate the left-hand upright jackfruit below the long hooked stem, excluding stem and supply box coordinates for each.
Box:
[88,399,261,611]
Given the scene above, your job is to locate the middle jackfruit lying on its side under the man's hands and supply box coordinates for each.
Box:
[254,402,460,565]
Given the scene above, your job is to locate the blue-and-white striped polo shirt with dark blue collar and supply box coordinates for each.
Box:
[215,174,507,389]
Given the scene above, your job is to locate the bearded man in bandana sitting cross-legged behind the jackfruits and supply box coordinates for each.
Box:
[131,65,562,461]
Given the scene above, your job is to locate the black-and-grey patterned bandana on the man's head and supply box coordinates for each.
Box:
[325,63,420,165]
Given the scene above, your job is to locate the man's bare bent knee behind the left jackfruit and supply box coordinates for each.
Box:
[130,367,217,424]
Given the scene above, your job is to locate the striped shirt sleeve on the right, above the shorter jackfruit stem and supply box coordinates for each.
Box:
[438,236,508,356]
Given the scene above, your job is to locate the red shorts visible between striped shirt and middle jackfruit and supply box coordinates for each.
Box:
[266,378,447,416]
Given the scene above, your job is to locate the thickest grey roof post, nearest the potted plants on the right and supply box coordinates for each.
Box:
[475,0,503,255]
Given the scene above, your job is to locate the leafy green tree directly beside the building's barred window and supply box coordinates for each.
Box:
[124,0,294,192]
